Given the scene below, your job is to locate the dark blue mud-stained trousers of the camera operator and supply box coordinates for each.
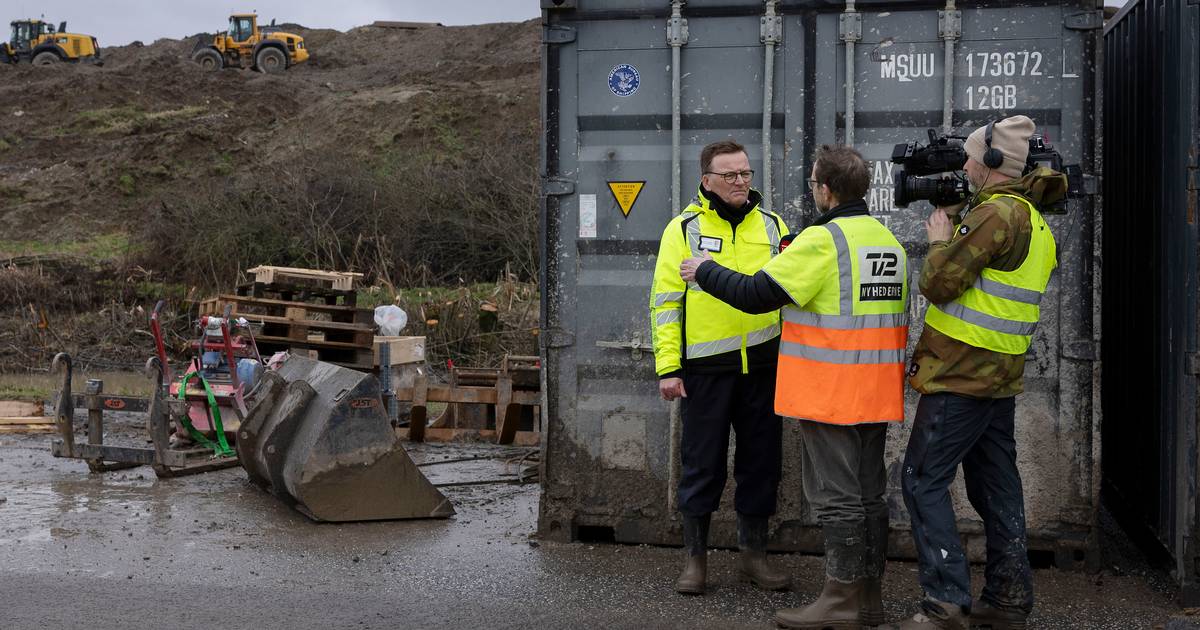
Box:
[901,394,1033,612]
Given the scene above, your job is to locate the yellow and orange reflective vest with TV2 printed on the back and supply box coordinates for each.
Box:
[763,215,908,425]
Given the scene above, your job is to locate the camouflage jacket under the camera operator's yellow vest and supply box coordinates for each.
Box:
[908,168,1067,398]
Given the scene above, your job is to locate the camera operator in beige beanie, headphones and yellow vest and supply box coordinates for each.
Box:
[900,116,1067,630]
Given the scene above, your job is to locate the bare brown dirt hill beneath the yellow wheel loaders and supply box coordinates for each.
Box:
[0,20,540,282]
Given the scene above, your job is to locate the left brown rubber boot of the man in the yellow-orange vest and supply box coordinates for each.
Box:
[775,524,866,630]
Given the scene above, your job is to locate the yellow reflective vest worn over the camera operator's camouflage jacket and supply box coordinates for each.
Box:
[925,194,1057,354]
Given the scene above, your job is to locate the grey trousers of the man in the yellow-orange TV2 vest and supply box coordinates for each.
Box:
[788,420,888,527]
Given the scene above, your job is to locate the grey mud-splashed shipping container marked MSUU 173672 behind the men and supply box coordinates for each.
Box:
[539,0,1103,564]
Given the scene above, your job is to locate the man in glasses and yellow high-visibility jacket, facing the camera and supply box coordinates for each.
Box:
[650,140,790,594]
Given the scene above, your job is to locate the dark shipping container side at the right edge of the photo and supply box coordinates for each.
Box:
[1100,0,1200,606]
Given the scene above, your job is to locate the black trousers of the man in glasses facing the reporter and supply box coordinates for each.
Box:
[678,370,782,516]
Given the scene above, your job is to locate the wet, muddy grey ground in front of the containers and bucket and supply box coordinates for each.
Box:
[0,410,1196,630]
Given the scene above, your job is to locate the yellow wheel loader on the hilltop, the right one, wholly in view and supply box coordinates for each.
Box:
[192,13,308,73]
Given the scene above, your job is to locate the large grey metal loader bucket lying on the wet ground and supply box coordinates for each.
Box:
[238,356,454,522]
